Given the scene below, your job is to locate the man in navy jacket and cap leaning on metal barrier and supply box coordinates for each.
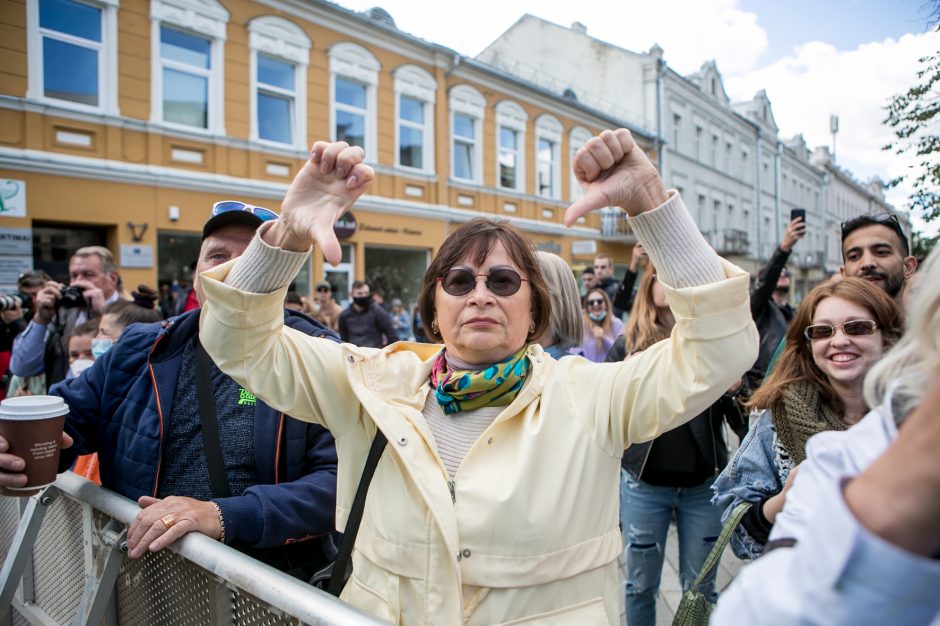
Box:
[0,208,338,574]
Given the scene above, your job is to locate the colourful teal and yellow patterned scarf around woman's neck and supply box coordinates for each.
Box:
[431,346,531,415]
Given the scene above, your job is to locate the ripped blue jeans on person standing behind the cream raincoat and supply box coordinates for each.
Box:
[620,469,721,626]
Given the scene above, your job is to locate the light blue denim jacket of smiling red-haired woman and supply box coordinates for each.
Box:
[712,409,793,559]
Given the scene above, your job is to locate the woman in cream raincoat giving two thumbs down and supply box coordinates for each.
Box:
[195,129,757,625]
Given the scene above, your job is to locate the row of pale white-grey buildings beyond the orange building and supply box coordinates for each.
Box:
[477,15,904,288]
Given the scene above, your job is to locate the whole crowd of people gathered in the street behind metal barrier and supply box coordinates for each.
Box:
[0,129,940,626]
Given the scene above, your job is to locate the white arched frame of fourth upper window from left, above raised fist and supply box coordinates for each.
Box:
[329,41,382,163]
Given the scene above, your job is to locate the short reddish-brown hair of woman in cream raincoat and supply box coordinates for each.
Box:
[418,217,552,341]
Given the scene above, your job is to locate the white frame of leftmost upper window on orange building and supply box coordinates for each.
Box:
[26,0,119,115]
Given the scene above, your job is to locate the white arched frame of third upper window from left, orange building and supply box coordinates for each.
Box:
[248,15,312,150]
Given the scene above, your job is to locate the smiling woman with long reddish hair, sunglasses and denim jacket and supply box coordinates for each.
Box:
[712,278,902,559]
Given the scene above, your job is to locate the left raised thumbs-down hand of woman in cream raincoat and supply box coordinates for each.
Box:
[264,141,375,265]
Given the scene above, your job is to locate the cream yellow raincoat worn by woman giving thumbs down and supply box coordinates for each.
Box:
[200,262,758,625]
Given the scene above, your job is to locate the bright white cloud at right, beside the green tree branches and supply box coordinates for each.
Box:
[724,32,940,231]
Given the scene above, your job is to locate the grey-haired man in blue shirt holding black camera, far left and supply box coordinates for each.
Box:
[10,246,120,386]
